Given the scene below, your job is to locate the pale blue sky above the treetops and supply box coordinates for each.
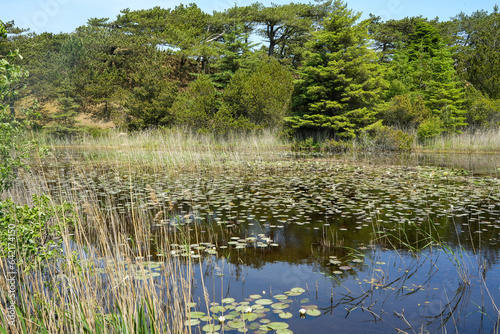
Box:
[0,0,498,33]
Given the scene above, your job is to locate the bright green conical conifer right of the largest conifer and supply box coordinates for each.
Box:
[382,21,467,133]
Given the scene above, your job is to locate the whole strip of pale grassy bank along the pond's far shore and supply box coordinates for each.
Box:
[36,128,500,156]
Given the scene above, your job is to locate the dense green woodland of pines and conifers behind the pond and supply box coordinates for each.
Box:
[0,0,500,140]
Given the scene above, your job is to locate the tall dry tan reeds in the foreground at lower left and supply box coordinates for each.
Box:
[0,158,224,333]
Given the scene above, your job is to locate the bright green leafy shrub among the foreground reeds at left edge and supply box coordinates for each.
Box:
[0,195,73,271]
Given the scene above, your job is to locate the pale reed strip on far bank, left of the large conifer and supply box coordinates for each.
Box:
[39,129,289,172]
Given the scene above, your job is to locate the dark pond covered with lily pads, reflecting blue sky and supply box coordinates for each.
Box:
[34,150,500,334]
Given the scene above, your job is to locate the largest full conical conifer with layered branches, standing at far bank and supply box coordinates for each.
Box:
[287,1,385,137]
